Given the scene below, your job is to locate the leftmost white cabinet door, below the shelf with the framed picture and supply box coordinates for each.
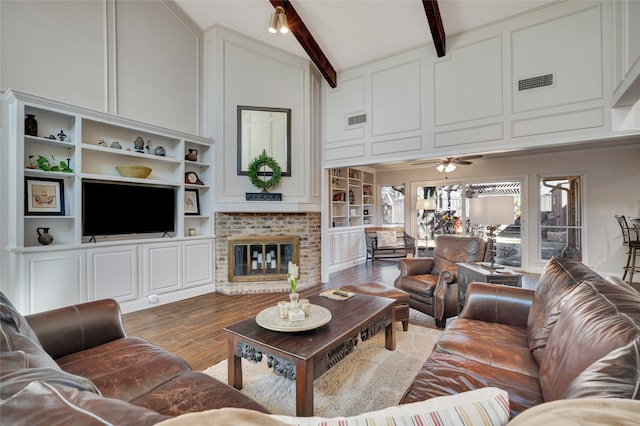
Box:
[24,250,87,313]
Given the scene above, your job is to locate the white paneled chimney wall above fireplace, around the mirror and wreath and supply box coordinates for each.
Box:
[205,27,320,211]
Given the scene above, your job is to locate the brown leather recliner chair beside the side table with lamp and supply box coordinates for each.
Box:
[394,235,487,328]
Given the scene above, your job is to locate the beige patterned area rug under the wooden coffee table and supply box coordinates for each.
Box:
[204,323,442,417]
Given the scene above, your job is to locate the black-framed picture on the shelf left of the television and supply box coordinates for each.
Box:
[24,176,64,216]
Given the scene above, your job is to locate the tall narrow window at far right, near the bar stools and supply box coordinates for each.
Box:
[540,176,582,261]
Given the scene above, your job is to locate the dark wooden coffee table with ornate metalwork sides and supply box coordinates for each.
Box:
[225,294,396,416]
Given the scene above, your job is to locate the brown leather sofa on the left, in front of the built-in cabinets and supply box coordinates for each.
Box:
[0,292,266,426]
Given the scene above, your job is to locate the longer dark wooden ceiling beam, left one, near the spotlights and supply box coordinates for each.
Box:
[269,0,338,87]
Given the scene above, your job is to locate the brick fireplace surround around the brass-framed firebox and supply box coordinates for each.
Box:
[214,212,321,295]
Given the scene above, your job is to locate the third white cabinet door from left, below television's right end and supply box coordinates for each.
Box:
[142,243,182,295]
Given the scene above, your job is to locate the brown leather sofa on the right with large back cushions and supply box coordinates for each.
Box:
[401,258,640,416]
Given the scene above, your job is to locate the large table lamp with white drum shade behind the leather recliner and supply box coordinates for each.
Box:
[469,196,513,271]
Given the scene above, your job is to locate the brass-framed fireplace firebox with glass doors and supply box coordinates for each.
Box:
[227,235,299,282]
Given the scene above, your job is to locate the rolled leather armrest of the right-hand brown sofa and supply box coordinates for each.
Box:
[458,282,535,327]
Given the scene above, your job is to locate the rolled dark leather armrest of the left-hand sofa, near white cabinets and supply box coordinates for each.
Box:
[26,299,127,359]
